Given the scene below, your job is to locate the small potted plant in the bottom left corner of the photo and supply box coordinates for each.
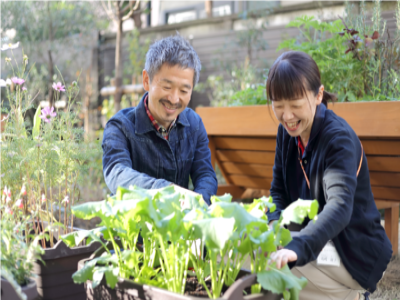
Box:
[0,212,43,300]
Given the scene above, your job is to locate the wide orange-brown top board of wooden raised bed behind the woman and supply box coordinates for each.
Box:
[196,101,400,138]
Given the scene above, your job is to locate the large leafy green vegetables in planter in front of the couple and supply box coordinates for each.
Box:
[63,186,318,299]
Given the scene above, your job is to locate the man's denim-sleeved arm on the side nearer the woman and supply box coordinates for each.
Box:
[190,120,218,204]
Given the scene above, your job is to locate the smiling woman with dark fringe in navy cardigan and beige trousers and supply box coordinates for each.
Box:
[267,51,392,300]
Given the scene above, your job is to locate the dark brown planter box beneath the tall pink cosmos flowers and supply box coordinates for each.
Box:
[33,240,100,300]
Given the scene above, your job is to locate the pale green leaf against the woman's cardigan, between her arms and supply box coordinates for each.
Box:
[281,199,318,225]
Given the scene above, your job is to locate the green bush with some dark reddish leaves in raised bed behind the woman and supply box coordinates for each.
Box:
[278,1,400,101]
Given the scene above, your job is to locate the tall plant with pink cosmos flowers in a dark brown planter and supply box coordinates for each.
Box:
[0,44,100,299]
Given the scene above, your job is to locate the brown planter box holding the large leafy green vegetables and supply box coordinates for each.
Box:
[78,259,282,300]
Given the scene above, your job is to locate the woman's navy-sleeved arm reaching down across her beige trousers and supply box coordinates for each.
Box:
[285,131,361,266]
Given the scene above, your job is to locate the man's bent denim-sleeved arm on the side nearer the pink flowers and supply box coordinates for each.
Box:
[102,121,171,194]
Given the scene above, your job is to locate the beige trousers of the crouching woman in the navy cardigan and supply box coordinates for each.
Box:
[292,261,365,300]
